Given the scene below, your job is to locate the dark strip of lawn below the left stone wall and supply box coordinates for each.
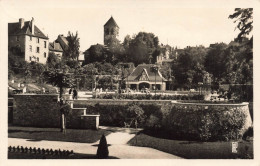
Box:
[8,126,111,143]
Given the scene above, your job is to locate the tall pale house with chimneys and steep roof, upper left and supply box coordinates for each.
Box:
[8,18,49,64]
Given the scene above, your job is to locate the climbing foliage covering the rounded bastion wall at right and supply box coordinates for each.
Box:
[162,106,246,141]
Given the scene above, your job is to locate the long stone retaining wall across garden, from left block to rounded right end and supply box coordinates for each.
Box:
[13,94,252,140]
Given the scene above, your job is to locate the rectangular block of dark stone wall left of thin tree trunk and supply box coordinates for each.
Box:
[13,94,60,127]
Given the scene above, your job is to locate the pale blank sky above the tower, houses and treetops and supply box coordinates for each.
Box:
[2,0,256,51]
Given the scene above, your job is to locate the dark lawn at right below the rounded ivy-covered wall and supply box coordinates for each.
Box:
[128,132,253,159]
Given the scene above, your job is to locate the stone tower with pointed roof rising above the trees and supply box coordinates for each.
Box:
[104,16,119,45]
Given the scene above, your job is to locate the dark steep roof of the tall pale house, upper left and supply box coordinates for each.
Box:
[8,21,48,39]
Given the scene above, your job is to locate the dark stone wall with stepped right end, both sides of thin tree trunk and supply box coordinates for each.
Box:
[12,94,99,129]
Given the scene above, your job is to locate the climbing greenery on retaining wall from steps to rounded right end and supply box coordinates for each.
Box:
[79,102,250,141]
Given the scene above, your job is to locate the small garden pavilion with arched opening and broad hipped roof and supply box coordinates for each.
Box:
[125,64,167,91]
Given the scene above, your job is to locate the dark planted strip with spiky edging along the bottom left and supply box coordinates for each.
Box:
[8,152,117,159]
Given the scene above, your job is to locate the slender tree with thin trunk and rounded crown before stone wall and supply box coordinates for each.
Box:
[44,69,75,133]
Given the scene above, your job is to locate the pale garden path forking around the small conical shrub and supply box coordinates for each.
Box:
[8,126,183,159]
